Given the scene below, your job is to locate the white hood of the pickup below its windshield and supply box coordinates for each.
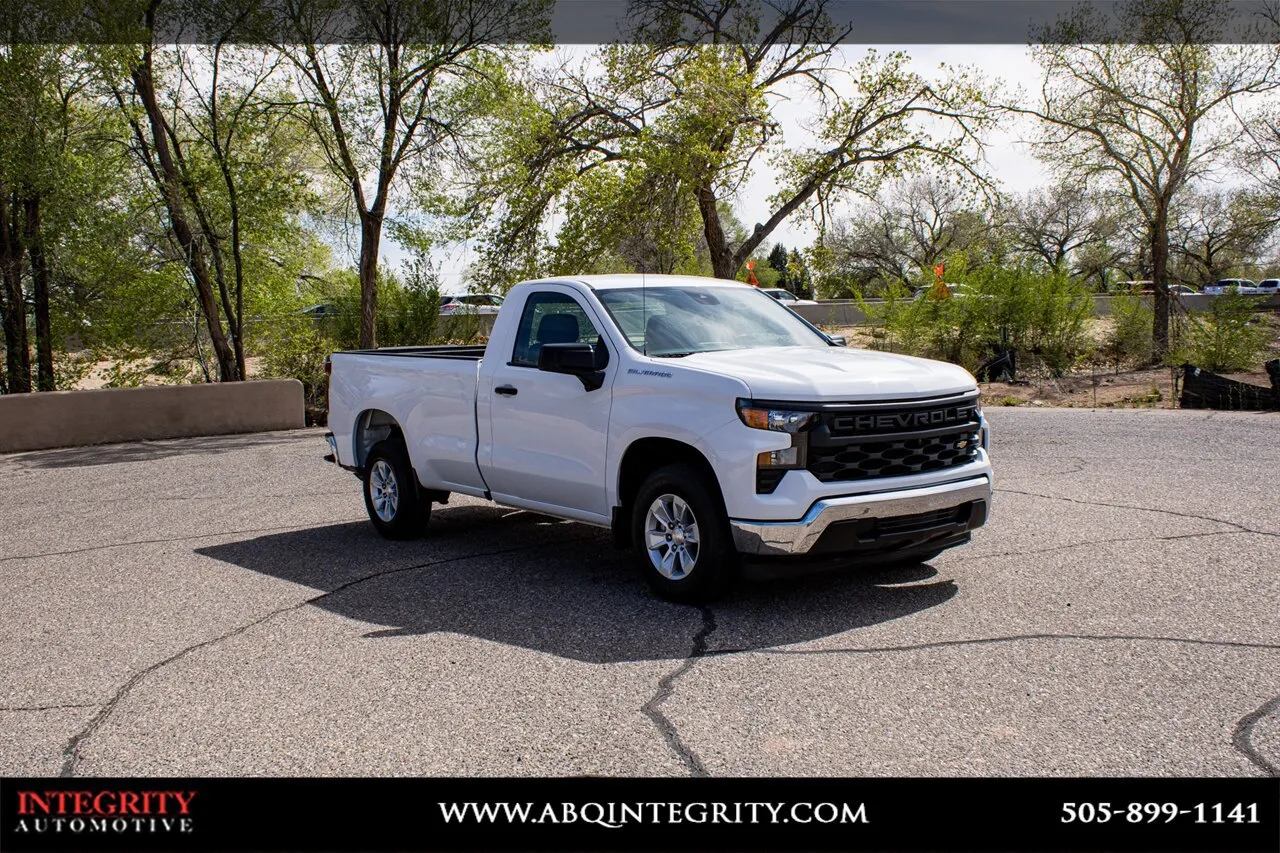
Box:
[676,347,978,402]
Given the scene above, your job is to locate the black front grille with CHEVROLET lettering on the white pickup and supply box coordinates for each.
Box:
[806,397,982,483]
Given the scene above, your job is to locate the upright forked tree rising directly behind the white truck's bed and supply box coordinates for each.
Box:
[276,0,549,348]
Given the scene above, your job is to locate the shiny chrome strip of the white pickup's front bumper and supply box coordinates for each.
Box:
[730,475,991,556]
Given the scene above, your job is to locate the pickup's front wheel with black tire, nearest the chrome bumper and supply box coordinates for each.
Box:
[631,465,739,596]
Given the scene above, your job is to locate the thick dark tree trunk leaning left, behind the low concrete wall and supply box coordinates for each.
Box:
[132,57,241,382]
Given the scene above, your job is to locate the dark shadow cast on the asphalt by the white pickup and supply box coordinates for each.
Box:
[196,506,956,663]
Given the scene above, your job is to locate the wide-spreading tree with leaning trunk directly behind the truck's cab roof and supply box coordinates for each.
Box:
[465,0,989,280]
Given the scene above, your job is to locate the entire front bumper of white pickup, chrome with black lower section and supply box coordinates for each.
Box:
[730,475,992,556]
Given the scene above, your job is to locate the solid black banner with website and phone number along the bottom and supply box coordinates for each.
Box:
[0,777,1280,853]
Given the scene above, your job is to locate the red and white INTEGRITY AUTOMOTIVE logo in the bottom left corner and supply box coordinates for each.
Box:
[12,790,196,835]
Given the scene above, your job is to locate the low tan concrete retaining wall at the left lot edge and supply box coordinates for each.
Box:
[0,379,305,453]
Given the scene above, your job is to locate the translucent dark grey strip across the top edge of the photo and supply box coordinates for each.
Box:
[0,0,1277,45]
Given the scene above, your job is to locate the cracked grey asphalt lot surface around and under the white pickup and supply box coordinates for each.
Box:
[0,409,1280,776]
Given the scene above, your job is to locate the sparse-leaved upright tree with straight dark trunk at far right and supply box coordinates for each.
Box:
[1010,0,1280,357]
